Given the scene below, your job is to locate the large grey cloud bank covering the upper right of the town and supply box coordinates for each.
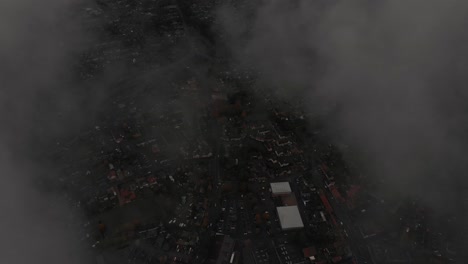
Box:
[218,0,468,209]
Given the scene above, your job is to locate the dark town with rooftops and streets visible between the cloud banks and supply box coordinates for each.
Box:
[10,0,460,264]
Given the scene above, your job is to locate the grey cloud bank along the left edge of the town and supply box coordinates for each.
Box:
[0,0,96,264]
